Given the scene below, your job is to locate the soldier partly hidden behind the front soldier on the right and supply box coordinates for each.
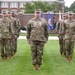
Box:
[56,14,66,56]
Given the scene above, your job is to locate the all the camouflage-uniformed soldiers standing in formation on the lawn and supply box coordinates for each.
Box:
[0,9,75,70]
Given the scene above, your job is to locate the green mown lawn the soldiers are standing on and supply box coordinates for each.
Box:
[0,40,75,75]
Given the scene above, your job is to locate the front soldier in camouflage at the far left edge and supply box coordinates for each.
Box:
[0,13,13,60]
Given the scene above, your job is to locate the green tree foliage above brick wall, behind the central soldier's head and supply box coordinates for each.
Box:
[24,1,60,13]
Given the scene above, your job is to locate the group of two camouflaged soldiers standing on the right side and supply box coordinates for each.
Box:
[56,11,75,62]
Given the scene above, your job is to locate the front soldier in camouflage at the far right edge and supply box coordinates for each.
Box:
[64,11,75,62]
